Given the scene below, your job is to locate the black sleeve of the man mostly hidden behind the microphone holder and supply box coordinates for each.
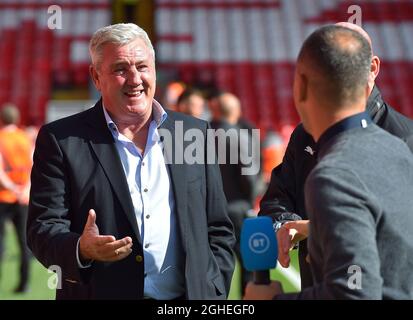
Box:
[258,129,301,222]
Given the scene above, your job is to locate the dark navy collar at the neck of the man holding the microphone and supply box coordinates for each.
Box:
[317,111,372,150]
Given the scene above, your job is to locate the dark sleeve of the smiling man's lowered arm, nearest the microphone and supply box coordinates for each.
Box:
[205,125,235,296]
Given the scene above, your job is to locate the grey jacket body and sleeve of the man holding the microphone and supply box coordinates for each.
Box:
[306,124,413,299]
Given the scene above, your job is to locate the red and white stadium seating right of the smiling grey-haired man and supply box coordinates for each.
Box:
[155,0,413,130]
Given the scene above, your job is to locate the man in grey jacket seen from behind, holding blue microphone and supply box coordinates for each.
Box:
[246,25,413,299]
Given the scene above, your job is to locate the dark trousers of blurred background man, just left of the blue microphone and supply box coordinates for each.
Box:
[228,200,252,297]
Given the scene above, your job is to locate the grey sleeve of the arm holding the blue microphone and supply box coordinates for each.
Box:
[278,168,383,299]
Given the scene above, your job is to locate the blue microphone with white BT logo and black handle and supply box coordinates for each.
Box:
[241,217,278,284]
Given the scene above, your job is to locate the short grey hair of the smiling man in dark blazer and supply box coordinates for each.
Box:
[89,23,155,68]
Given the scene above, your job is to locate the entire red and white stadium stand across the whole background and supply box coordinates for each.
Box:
[0,0,413,131]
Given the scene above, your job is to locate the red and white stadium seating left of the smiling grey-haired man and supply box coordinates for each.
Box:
[0,0,111,125]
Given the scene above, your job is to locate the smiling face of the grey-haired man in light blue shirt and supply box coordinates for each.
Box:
[91,39,156,119]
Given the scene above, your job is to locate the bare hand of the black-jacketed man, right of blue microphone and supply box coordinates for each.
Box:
[277,220,310,268]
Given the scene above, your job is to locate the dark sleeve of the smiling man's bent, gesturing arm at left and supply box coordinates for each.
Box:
[27,127,90,281]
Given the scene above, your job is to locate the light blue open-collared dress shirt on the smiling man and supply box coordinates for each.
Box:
[103,100,185,299]
